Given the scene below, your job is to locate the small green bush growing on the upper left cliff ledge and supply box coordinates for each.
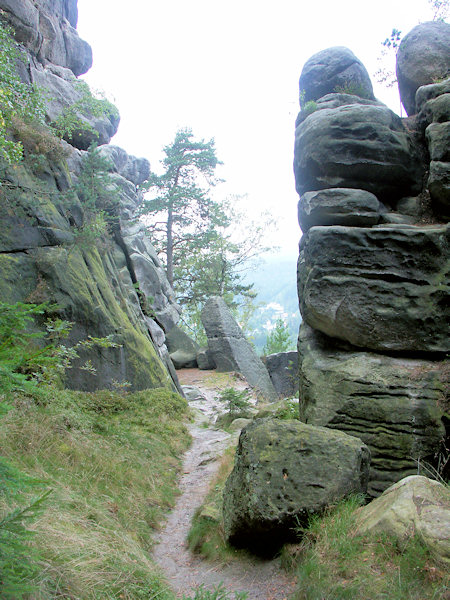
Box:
[51,79,119,142]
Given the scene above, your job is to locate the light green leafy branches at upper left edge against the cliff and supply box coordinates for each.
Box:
[0,15,44,164]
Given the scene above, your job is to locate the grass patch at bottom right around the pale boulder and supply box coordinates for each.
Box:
[282,497,450,600]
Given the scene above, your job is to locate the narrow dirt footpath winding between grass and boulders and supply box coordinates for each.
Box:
[153,369,294,600]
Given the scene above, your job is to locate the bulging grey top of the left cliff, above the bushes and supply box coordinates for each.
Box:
[0,0,119,150]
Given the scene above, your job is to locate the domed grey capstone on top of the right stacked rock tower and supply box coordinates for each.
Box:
[299,46,374,104]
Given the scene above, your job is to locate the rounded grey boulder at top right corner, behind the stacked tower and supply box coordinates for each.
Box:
[397,21,450,115]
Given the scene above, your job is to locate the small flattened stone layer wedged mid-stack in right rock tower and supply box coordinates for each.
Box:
[298,188,386,233]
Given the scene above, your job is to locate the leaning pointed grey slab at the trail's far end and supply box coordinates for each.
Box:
[202,296,277,400]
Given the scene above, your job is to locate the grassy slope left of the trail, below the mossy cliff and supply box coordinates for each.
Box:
[0,388,190,600]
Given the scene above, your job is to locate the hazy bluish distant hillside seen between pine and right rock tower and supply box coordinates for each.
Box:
[245,255,301,353]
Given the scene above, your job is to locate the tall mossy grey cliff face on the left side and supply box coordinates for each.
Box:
[0,0,181,391]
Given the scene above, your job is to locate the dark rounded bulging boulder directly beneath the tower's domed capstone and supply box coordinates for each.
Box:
[294,94,424,203]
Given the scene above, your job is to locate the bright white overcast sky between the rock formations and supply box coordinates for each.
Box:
[78,0,438,254]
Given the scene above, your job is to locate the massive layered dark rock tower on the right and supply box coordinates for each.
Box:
[294,39,450,496]
